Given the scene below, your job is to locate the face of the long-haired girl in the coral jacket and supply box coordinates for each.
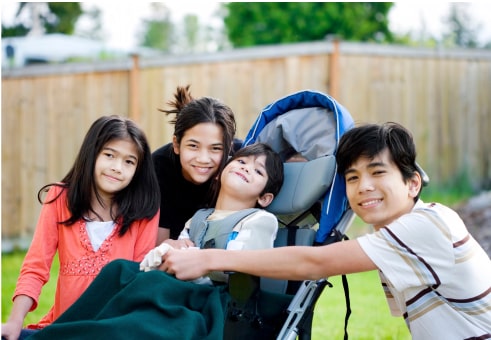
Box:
[94,139,138,197]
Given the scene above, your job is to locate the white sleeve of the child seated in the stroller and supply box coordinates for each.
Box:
[227,210,278,250]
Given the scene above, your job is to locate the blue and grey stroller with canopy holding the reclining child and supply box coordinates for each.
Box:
[224,90,354,340]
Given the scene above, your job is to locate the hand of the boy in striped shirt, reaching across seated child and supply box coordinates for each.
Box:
[159,248,209,280]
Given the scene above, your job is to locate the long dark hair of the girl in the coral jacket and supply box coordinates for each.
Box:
[38,115,160,236]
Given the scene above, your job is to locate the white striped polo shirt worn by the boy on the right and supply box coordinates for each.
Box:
[358,201,491,339]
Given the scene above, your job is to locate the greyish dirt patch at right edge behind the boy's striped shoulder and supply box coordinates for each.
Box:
[454,191,491,257]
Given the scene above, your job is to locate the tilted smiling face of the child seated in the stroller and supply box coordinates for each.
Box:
[220,155,268,207]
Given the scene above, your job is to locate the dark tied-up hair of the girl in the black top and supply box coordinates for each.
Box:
[159,85,236,169]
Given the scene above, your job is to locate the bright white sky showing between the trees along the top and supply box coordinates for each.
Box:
[2,0,491,51]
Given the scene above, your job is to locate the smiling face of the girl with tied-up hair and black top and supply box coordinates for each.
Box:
[173,123,224,184]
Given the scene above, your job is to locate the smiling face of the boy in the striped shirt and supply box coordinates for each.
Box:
[345,149,421,230]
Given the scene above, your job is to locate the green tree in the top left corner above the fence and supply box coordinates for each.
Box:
[2,2,83,38]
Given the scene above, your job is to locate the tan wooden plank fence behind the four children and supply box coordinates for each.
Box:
[1,41,491,244]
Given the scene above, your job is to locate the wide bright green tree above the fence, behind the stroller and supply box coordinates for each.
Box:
[222,2,393,47]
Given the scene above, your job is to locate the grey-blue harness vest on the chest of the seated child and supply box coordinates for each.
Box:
[189,208,259,249]
